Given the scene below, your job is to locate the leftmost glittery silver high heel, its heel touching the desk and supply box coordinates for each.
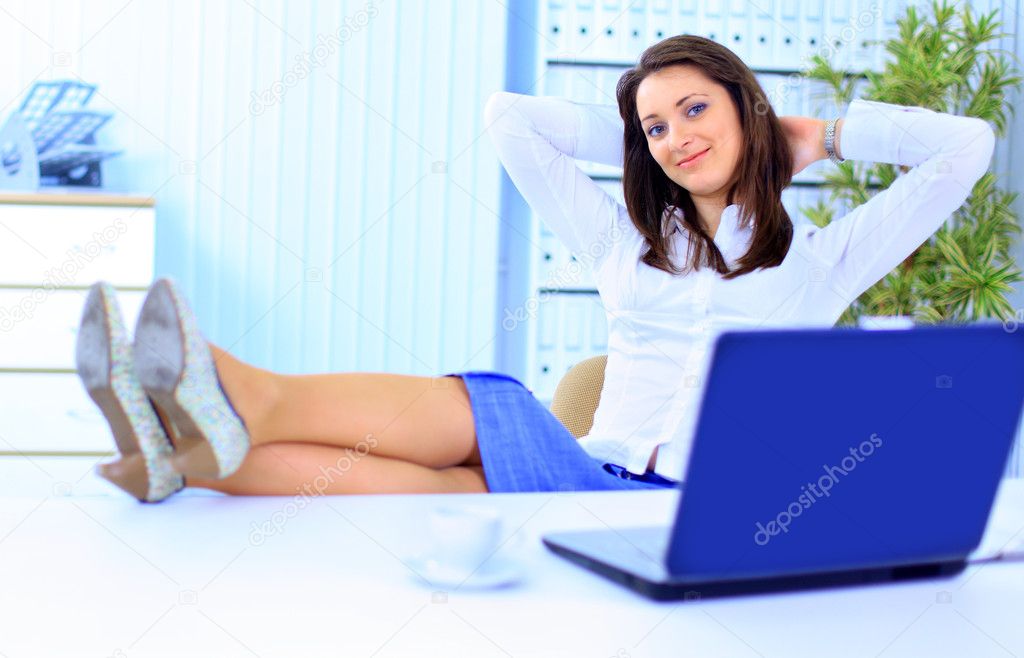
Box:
[75,281,184,502]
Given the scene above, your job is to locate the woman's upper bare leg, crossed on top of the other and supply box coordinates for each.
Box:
[210,345,480,473]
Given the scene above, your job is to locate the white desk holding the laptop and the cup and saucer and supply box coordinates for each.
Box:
[0,464,1024,658]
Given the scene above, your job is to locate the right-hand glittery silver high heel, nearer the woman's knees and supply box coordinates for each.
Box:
[135,278,249,479]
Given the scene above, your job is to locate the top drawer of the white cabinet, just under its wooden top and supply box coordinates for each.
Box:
[0,204,156,287]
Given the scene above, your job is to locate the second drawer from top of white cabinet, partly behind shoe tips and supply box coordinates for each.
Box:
[0,288,145,368]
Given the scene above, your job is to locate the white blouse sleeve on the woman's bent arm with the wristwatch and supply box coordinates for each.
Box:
[808,100,995,306]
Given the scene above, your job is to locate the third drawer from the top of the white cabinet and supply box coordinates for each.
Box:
[0,372,116,452]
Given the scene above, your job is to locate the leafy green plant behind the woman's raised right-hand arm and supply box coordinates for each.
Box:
[802,0,1022,324]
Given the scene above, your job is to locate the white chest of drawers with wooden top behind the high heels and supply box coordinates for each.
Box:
[0,193,156,455]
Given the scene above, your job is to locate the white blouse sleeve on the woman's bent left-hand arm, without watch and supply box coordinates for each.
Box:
[484,91,628,267]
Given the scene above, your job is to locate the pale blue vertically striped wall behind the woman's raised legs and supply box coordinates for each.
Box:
[0,0,506,374]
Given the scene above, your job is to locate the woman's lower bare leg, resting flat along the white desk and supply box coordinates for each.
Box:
[185,443,487,495]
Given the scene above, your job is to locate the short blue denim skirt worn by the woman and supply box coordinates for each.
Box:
[446,370,679,493]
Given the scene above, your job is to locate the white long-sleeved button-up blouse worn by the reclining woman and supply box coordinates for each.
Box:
[484,92,995,480]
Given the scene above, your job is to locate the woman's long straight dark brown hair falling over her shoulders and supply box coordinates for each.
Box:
[615,35,793,278]
